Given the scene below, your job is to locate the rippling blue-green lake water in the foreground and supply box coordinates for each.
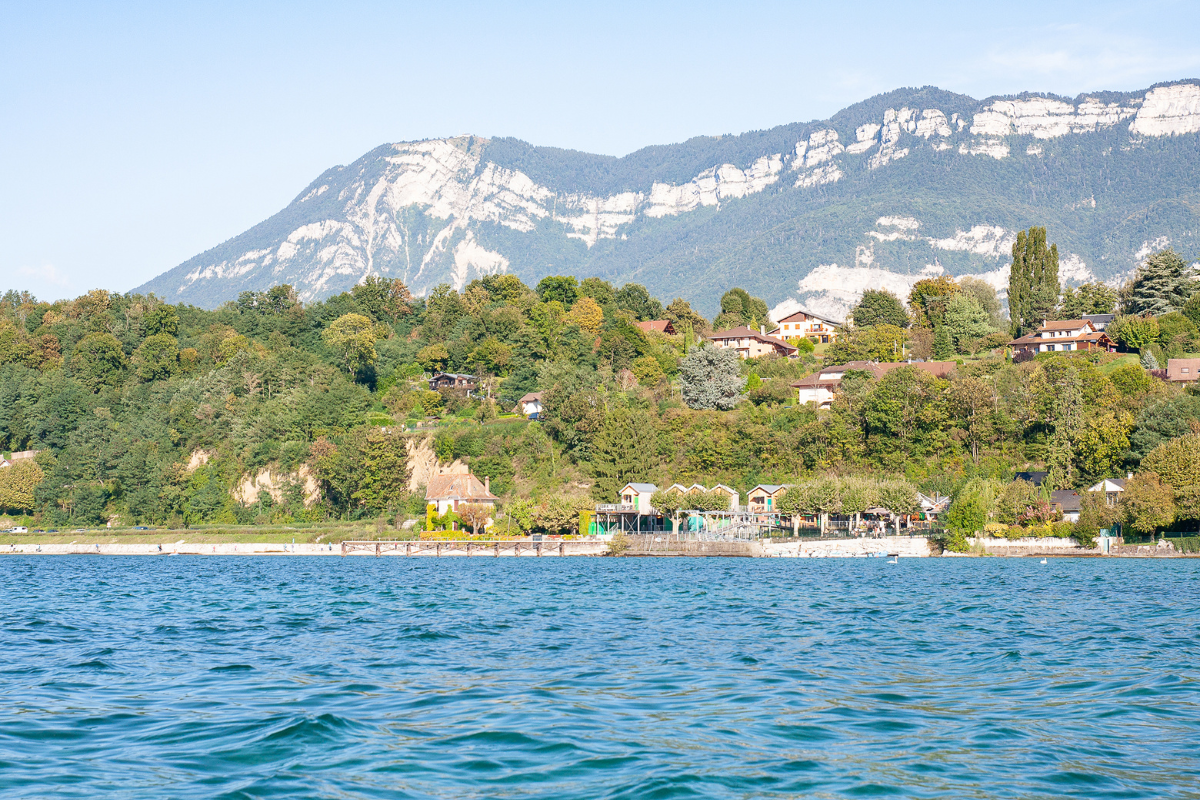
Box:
[0,557,1200,799]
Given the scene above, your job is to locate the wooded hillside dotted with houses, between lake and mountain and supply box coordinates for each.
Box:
[0,229,1200,548]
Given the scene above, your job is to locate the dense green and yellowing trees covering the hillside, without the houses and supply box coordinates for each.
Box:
[0,250,1200,542]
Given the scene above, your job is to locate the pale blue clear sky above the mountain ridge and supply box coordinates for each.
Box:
[0,0,1200,300]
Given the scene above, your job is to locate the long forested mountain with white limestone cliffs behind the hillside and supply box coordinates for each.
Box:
[138,80,1200,314]
